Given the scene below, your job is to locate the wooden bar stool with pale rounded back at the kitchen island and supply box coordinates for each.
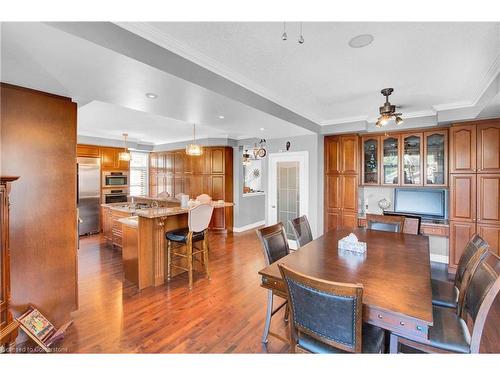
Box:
[165,204,214,289]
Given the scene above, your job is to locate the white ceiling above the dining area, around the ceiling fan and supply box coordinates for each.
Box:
[119,22,500,125]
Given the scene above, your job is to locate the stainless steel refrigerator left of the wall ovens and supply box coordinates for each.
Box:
[77,158,101,236]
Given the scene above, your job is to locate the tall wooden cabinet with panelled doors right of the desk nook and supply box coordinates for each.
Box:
[449,119,500,271]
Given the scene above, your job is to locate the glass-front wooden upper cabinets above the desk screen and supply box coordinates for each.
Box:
[361,129,448,186]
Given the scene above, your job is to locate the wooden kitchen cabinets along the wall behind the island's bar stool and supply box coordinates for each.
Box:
[149,147,233,231]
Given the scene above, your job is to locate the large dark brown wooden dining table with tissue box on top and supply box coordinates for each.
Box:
[259,228,433,341]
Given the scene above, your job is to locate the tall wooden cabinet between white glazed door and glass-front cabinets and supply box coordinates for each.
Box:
[324,135,364,231]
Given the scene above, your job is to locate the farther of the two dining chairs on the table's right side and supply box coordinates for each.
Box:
[431,234,488,308]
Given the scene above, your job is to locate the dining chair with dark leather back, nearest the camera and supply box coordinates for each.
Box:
[278,264,385,354]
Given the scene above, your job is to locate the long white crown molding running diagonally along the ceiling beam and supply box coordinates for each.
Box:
[114,22,320,124]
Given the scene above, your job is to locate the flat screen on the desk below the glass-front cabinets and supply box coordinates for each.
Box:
[394,188,446,219]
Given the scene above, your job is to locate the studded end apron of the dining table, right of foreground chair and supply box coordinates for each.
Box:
[363,305,429,340]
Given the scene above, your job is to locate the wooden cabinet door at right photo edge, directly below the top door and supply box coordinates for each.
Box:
[477,174,500,225]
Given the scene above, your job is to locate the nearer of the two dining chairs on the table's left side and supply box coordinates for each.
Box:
[255,223,290,344]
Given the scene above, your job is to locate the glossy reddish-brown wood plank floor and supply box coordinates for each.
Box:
[63,231,500,353]
